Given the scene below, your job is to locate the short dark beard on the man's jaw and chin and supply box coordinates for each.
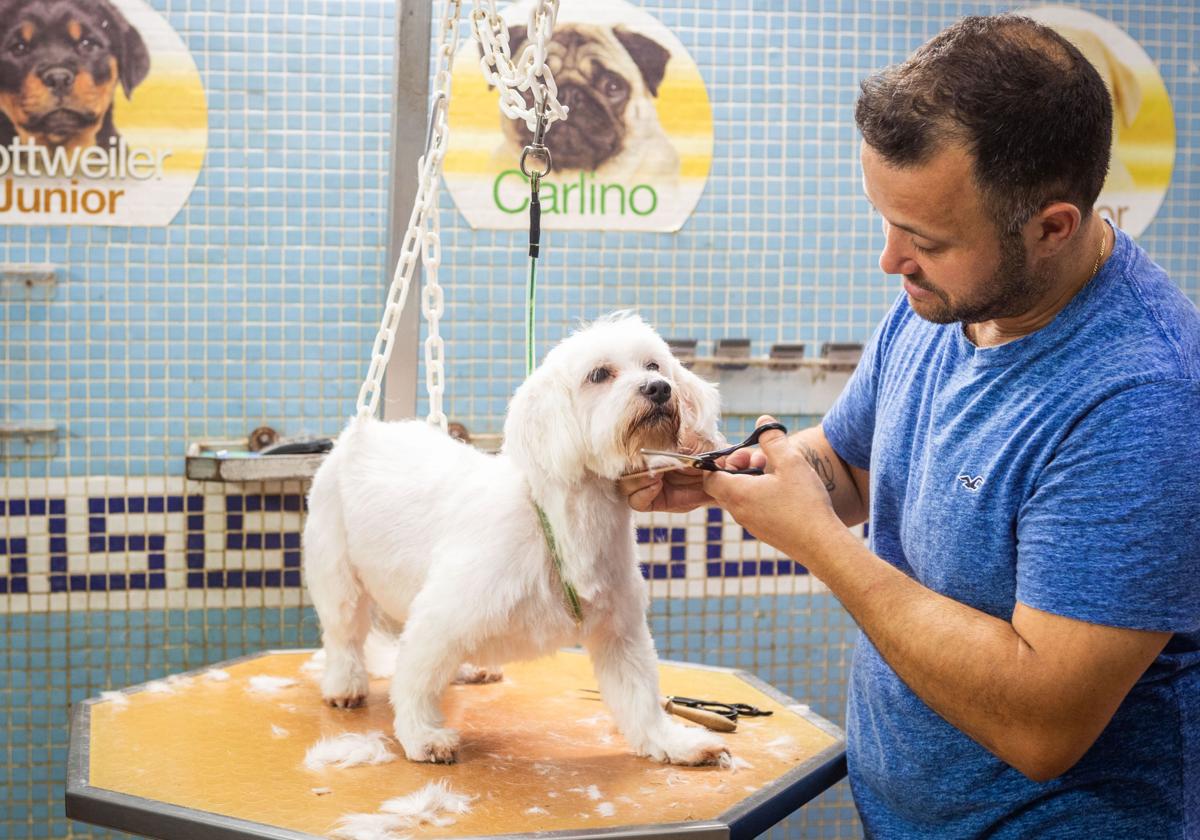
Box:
[905,234,1045,324]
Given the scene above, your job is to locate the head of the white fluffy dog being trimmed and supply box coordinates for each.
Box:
[504,313,721,484]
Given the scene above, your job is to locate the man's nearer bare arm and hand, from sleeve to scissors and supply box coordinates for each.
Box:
[704,422,1171,781]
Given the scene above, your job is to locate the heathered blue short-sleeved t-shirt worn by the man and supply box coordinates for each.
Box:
[822,224,1200,840]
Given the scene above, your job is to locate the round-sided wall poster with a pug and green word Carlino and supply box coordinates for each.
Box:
[444,0,713,230]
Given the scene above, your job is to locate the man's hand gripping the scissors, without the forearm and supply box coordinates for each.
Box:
[703,415,842,552]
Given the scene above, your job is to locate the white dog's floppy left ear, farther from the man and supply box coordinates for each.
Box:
[503,365,584,484]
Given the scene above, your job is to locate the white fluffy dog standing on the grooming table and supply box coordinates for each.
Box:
[304,313,727,764]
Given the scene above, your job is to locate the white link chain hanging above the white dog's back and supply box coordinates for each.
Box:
[358,0,566,432]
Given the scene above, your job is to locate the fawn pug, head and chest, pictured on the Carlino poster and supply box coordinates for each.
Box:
[497,23,679,181]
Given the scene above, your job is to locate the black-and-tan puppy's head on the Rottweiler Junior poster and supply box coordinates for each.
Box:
[0,0,150,146]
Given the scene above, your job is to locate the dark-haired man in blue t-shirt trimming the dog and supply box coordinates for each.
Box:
[623,16,1200,840]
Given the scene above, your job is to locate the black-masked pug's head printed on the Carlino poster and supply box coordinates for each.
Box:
[504,24,671,172]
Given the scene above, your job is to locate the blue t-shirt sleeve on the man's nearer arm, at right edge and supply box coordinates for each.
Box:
[1016,382,1200,632]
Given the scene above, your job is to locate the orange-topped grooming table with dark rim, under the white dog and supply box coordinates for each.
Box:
[66,650,846,840]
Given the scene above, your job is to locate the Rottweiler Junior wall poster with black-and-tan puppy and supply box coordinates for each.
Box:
[0,0,208,226]
